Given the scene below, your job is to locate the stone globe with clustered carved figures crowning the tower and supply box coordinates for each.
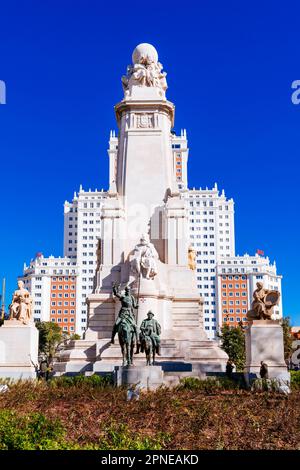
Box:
[122,43,168,96]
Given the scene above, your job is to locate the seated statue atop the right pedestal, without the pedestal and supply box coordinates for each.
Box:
[247,282,280,320]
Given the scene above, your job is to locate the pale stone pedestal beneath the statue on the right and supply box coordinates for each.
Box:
[245,320,290,383]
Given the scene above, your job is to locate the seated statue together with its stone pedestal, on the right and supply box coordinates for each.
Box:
[245,282,290,387]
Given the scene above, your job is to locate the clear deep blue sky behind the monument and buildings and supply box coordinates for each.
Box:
[0,0,300,324]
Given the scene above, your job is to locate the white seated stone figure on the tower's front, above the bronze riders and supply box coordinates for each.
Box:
[130,235,159,279]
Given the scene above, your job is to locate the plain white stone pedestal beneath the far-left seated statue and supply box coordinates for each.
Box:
[0,320,39,380]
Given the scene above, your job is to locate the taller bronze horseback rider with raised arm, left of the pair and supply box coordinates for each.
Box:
[111,284,138,366]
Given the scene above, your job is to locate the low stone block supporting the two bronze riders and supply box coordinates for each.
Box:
[115,366,164,390]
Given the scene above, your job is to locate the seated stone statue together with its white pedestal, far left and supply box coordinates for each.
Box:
[0,281,39,379]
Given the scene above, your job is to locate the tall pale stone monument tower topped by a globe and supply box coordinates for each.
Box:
[55,44,227,382]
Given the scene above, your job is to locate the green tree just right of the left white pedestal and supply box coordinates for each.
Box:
[36,322,80,366]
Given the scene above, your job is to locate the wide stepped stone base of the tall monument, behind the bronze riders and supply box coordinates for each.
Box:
[54,338,228,386]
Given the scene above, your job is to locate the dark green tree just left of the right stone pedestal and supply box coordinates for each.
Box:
[218,323,246,371]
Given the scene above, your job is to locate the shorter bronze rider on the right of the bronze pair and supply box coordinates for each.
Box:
[137,310,161,365]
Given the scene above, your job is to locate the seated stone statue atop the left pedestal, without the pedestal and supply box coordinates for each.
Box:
[9,281,32,325]
